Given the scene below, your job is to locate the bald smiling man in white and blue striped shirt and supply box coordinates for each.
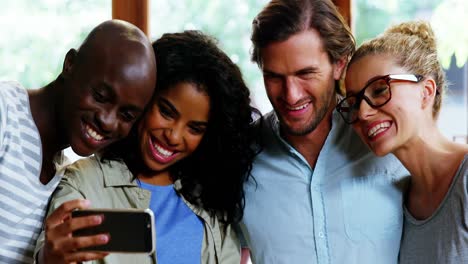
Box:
[0,20,156,263]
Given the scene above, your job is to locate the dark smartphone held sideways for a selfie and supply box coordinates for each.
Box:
[72,209,155,254]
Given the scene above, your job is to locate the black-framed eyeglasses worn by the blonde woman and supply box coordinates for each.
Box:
[336,74,424,124]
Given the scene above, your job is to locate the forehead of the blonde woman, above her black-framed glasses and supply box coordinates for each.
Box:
[345,54,406,93]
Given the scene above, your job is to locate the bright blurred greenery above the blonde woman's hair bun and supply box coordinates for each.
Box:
[353,0,468,69]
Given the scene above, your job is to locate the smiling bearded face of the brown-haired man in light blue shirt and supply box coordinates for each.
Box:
[261,29,344,136]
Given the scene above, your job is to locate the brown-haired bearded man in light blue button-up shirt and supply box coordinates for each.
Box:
[241,0,408,264]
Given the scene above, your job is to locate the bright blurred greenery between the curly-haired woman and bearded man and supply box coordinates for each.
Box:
[150,0,271,110]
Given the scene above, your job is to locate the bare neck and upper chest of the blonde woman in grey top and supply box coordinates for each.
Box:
[394,129,468,219]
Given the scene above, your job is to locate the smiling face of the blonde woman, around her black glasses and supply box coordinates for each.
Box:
[345,54,427,156]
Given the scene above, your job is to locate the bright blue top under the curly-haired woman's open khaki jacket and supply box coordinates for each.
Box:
[140,181,204,264]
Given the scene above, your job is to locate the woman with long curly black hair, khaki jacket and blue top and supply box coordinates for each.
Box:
[34,31,259,264]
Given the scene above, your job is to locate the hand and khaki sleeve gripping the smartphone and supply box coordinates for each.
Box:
[35,165,108,263]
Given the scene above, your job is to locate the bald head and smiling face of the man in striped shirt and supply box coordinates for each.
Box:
[57,28,156,156]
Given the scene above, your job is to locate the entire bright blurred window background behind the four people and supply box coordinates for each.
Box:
[0,0,468,163]
